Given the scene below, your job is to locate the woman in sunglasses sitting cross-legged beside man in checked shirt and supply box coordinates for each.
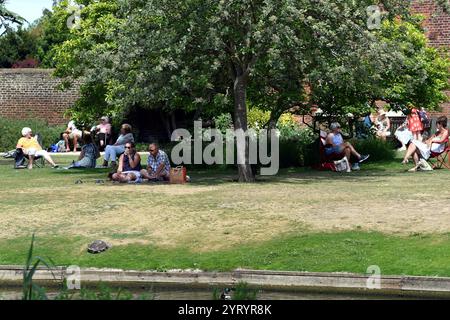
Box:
[111,142,142,183]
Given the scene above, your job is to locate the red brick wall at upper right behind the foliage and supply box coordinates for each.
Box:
[411,0,450,118]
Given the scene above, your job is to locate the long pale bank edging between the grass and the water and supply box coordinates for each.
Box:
[0,266,450,298]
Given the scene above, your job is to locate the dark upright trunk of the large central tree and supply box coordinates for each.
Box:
[233,75,255,182]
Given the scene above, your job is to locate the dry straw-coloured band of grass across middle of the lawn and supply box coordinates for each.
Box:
[0,171,450,251]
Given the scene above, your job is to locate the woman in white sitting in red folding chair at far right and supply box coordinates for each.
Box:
[402,116,449,172]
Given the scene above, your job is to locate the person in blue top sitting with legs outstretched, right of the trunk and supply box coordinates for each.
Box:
[325,122,369,170]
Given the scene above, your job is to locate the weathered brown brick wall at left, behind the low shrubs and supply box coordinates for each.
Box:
[0,69,78,125]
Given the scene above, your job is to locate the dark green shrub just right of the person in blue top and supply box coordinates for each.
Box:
[352,138,395,161]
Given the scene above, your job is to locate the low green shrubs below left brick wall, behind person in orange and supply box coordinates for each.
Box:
[0,118,66,151]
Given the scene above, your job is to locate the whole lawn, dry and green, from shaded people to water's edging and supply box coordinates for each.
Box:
[0,156,450,276]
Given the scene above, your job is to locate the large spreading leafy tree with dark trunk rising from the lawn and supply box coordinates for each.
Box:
[51,0,450,181]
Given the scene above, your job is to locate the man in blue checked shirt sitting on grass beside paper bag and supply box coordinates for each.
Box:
[141,143,170,181]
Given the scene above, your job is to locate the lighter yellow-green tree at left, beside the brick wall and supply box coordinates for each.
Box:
[52,0,123,123]
